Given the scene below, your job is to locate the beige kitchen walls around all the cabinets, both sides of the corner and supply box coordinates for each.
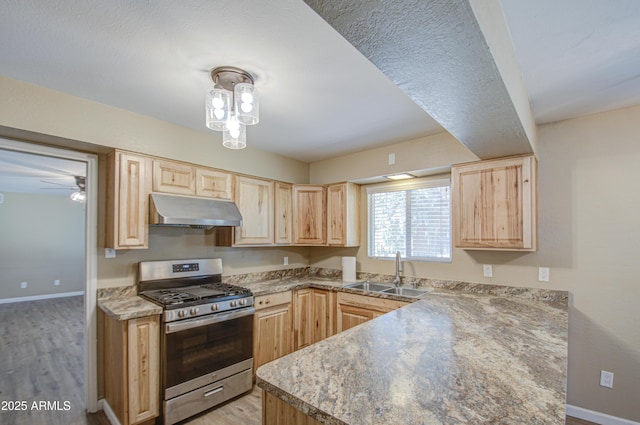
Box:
[0,77,640,421]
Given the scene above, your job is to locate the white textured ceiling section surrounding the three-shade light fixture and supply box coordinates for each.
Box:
[0,0,442,161]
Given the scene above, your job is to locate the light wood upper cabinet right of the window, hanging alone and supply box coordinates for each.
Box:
[451,155,538,251]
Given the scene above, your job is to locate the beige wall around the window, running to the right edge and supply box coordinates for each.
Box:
[309,107,640,421]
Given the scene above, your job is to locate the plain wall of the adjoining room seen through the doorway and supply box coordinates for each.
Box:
[0,192,85,299]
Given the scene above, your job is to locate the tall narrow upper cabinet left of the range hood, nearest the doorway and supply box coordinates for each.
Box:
[105,151,151,249]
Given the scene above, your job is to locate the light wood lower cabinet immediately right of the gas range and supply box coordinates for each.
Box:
[253,291,293,376]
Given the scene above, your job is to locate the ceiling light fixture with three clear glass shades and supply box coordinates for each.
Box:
[205,66,260,149]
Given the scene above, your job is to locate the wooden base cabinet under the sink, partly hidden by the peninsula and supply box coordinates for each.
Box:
[336,292,408,333]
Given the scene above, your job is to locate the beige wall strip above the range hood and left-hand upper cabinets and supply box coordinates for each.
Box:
[0,76,309,183]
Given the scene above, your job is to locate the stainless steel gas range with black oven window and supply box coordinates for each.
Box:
[139,258,255,425]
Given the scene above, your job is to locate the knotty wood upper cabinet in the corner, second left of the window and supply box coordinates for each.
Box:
[293,184,326,245]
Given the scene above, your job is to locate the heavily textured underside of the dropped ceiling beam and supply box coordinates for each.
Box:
[305,0,535,158]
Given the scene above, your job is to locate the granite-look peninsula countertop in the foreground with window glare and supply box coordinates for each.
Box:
[257,289,568,425]
